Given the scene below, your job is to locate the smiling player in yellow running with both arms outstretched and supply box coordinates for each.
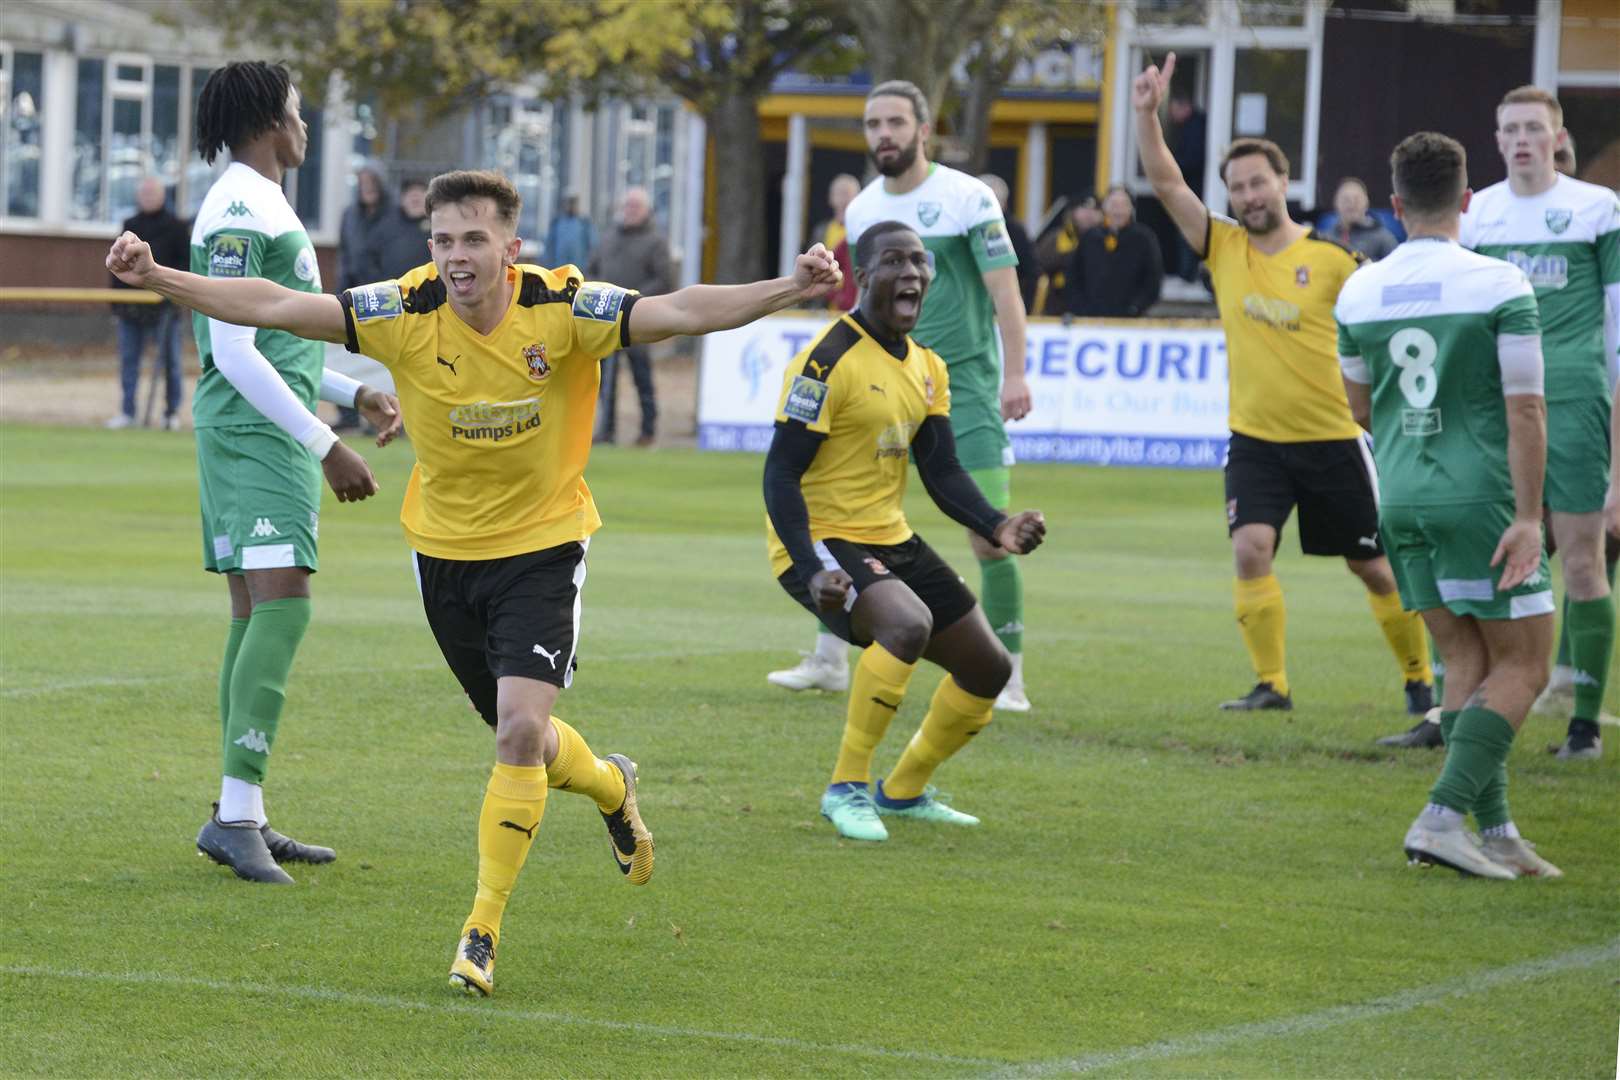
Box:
[107,172,842,994]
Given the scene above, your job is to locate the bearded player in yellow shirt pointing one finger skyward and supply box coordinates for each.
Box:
[1131,53,1434,716]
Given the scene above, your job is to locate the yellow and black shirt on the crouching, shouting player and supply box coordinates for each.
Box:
[765,316,951,576]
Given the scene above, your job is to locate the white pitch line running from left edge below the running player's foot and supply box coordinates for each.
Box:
[0,967,1003,1069]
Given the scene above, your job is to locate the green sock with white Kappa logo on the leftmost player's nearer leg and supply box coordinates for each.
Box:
[225,596,309,784]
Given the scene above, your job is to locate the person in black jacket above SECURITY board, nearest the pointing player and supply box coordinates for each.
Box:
[1068,188,1165,319]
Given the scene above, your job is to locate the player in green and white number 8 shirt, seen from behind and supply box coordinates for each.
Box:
[1335,131,1560,879]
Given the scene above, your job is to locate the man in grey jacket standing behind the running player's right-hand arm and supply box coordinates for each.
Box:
[585,188,669,447]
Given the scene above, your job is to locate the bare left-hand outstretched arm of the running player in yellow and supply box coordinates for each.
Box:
[107,233,348,342]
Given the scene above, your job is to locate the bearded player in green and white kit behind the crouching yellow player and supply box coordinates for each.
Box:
[770,81,1030,712]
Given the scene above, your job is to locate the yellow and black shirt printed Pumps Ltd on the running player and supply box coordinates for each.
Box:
[342,264,637,560]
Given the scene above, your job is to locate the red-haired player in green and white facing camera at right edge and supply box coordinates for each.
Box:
[1461,86,1620,759]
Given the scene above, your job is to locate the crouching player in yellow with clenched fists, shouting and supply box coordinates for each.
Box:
[765,222,1047,840]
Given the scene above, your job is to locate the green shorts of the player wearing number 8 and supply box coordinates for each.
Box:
[1379,502,1554,619]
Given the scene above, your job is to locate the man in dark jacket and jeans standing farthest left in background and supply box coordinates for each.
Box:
[107,176,191,431]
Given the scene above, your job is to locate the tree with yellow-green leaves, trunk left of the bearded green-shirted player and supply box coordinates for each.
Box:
[194,0,852,282]
